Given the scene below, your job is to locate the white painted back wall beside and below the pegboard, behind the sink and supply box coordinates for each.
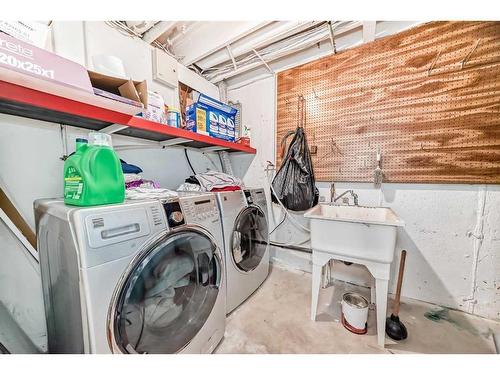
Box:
[229,77,500,319]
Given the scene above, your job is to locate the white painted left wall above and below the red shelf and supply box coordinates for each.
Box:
[0,22,224,350]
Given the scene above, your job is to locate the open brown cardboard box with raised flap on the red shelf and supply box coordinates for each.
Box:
[88,70,148,108]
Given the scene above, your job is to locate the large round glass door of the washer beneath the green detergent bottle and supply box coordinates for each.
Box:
[108,228,222,354]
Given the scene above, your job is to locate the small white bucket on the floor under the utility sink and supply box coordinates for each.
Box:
[341,292,369,335]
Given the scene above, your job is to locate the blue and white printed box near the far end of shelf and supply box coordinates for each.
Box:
[186,92,238,142]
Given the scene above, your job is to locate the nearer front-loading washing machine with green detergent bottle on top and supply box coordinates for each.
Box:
[35,194,226,354]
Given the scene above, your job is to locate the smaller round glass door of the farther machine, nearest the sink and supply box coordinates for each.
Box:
[231,206,269,272]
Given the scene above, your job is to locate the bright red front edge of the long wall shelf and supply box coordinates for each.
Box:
[0,81,257,154]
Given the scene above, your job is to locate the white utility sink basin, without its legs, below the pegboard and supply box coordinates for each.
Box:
[304,204,404,263]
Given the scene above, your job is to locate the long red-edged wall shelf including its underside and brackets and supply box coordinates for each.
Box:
[0,81,256,154]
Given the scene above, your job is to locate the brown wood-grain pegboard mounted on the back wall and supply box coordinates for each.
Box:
[276,22,500,184]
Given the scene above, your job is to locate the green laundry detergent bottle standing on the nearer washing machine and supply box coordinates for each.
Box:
[64,132,125,206]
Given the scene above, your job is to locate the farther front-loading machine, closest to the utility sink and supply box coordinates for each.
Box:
[217,189,269,314]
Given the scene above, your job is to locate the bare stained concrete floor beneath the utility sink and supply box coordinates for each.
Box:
[215,266,500,353]
